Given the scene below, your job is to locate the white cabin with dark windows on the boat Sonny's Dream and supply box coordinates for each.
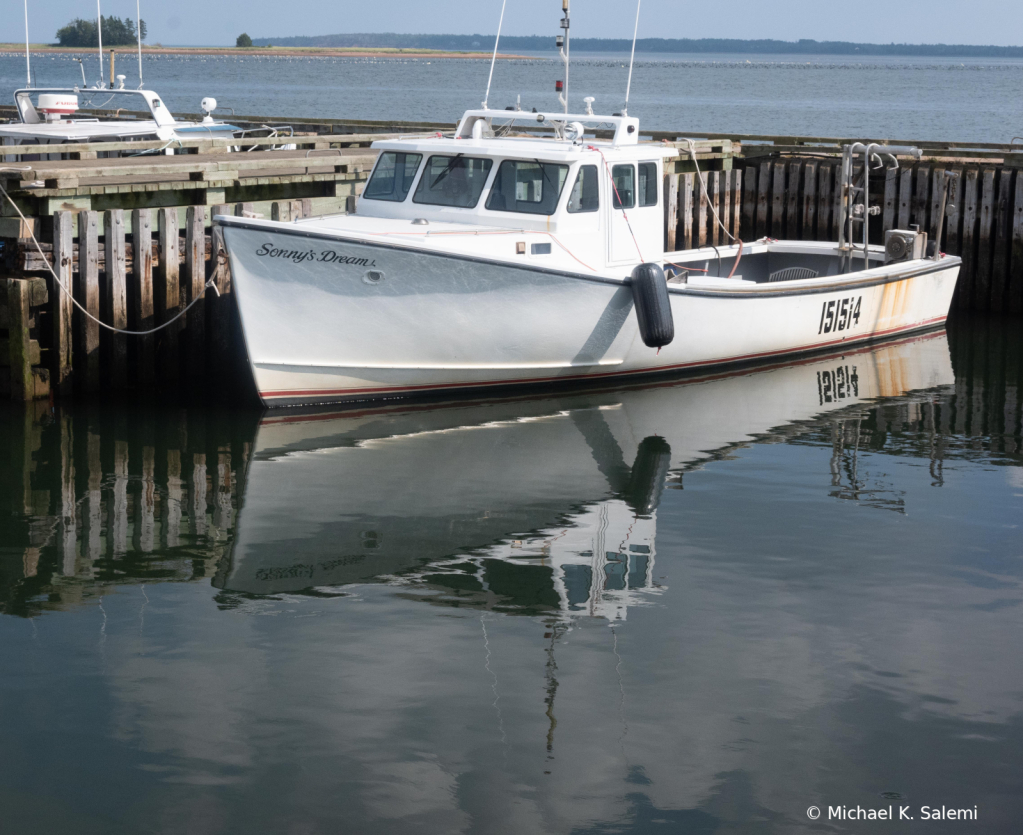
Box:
[357,111,677,268]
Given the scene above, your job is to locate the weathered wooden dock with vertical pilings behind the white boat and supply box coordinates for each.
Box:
[0,108,1023,400]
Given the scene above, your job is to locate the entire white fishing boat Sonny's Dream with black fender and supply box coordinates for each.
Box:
[218,1,960,405]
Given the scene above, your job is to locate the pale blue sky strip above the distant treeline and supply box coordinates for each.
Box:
[14,0,1023,46]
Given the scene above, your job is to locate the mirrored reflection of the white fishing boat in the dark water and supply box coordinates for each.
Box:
[213,333,954,620]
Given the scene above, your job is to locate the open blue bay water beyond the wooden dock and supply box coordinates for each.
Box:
[0,53,1023,142]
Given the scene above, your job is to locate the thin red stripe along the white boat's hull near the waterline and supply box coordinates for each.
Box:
[260,316,947,399]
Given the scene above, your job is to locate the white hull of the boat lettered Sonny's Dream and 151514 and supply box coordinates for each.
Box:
[224,221,959,405]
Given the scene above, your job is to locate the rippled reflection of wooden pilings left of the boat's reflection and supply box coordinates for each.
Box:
[0,402,255,613]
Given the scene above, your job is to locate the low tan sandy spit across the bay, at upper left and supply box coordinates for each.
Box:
[0,44,532,59]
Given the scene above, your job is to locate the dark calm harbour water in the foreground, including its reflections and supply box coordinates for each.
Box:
[0,320,1023,835]
